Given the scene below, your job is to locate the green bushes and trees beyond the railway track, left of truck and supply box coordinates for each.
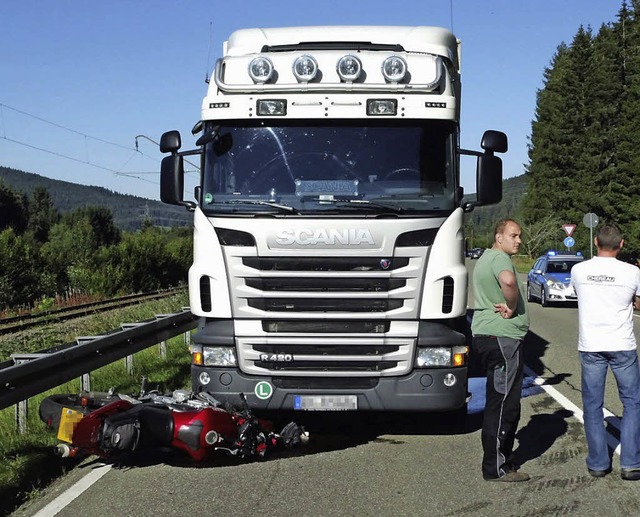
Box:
[0,180,193,311]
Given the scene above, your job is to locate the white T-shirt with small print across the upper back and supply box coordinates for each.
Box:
[571,257,640,352]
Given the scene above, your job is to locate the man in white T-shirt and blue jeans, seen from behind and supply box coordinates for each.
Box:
[571,225,640,481]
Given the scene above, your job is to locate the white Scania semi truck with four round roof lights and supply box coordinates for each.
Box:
[160,26,507,412]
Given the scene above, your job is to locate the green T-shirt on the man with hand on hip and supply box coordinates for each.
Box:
[471,249,529,339]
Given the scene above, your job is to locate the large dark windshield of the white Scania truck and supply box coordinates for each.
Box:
[199,120,456,216]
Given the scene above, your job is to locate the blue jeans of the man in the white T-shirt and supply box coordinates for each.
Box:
[580,350,640,470]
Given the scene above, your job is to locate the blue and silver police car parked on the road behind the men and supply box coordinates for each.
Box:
[527,251,584,307]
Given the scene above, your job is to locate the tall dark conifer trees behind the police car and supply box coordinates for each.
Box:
[518,0,640,257]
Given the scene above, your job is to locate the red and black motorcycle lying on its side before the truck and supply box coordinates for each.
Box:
[39,384,308,461]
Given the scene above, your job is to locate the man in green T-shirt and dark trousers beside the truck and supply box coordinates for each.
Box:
[471,219,529,482]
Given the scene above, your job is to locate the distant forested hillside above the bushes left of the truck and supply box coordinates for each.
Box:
[0,166,192,231]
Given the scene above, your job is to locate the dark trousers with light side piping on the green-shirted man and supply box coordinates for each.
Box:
[473,336,524,479]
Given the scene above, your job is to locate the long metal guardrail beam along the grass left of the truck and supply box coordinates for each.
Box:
[0,310,197,409]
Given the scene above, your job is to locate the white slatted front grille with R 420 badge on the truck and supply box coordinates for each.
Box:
[221,245,436,374]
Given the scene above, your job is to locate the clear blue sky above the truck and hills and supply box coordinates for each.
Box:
[0,0,622,199]
